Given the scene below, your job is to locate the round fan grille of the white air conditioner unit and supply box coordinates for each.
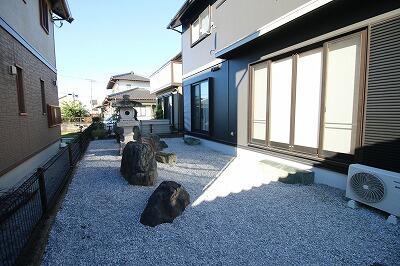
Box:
[350,173,385,203]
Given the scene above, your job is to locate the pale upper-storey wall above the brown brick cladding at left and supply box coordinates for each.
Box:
[0,0,56,66]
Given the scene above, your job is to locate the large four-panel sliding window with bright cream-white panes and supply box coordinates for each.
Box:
[248,31,366,160]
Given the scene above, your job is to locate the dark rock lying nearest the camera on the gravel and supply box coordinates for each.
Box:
[140,181,190,227]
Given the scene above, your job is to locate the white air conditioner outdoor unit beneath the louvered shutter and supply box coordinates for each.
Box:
[346,164,400,224]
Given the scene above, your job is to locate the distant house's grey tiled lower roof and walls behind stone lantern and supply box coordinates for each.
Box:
[103,88,156,120]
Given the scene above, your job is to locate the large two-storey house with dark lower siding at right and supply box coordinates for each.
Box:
[168,0,400,188]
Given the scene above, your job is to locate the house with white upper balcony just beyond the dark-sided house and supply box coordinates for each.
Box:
[150,53,183,131]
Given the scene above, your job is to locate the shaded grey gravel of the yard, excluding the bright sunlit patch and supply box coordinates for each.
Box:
[43,139,400,265]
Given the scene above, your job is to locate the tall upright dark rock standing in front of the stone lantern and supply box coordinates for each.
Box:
[120,141,157,186]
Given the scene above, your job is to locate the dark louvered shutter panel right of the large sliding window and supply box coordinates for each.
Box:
[363,18,400,174]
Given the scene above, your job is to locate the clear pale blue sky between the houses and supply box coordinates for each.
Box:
[55,0,184,107]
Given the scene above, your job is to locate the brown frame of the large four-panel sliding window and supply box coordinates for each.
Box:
[247,28,368,165]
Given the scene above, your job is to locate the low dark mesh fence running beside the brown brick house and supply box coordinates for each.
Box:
[0,126,92,266]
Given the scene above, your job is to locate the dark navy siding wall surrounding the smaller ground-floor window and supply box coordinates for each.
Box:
[183,61,237,144]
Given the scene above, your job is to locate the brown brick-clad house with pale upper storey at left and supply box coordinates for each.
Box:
[0,0,73,190]
